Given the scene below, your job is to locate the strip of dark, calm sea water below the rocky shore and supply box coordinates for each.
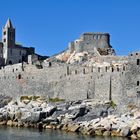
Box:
[0,127,128,140]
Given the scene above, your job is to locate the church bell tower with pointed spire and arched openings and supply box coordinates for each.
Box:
[2,19,15,64]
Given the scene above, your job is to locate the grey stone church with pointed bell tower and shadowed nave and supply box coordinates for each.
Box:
[0,19,35,66]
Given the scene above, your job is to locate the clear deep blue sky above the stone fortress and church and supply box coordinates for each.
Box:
[0,0,140,56]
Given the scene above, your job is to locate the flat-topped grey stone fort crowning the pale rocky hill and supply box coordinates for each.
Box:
[69,32,115,55]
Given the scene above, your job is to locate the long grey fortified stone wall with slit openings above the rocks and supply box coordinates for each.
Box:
[0,53,140,114]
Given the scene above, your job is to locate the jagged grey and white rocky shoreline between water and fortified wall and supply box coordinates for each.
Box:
[0,96,140,139]
